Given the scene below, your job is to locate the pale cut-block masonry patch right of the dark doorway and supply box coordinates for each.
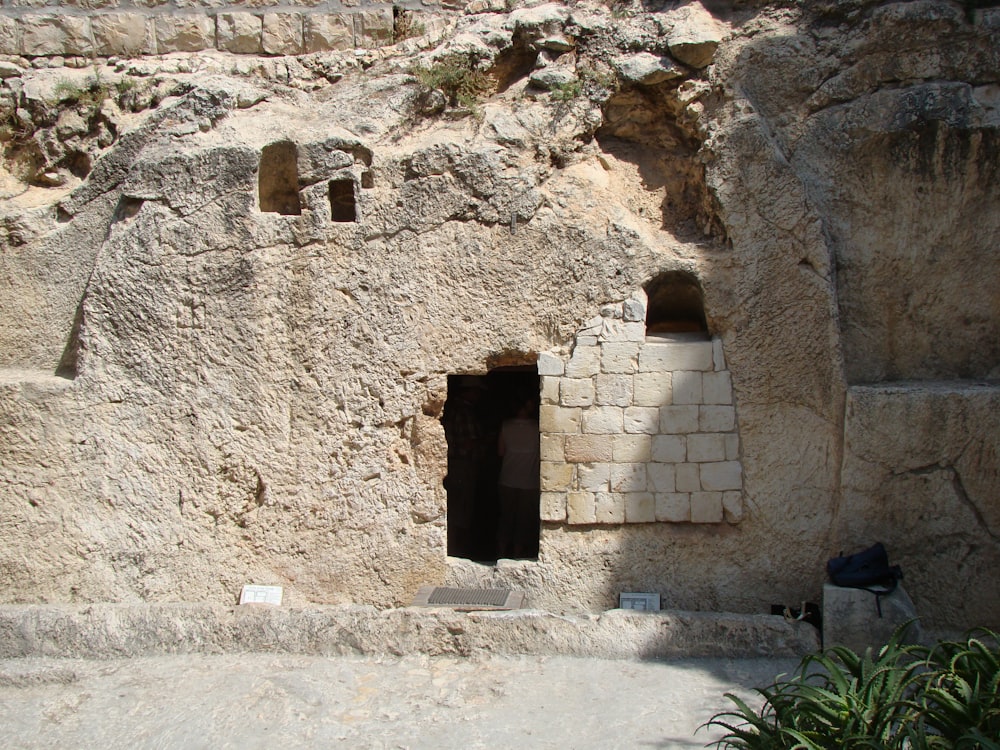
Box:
[538,299,743,524]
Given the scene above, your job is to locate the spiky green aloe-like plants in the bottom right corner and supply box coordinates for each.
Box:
[706,626,1000,750]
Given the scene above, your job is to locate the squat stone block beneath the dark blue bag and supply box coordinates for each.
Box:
[823,583,922,653]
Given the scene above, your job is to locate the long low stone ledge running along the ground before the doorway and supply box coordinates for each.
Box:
[0,604,819,659]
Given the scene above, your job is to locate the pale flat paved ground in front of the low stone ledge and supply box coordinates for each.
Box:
[0,654,796,750]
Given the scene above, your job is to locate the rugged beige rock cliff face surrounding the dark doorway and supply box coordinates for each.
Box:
[0,0,1000,628]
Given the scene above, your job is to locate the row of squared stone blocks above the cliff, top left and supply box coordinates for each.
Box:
[0,0,454,57]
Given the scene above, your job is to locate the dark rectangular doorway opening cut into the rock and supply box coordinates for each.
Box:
[441,365,541,562]
